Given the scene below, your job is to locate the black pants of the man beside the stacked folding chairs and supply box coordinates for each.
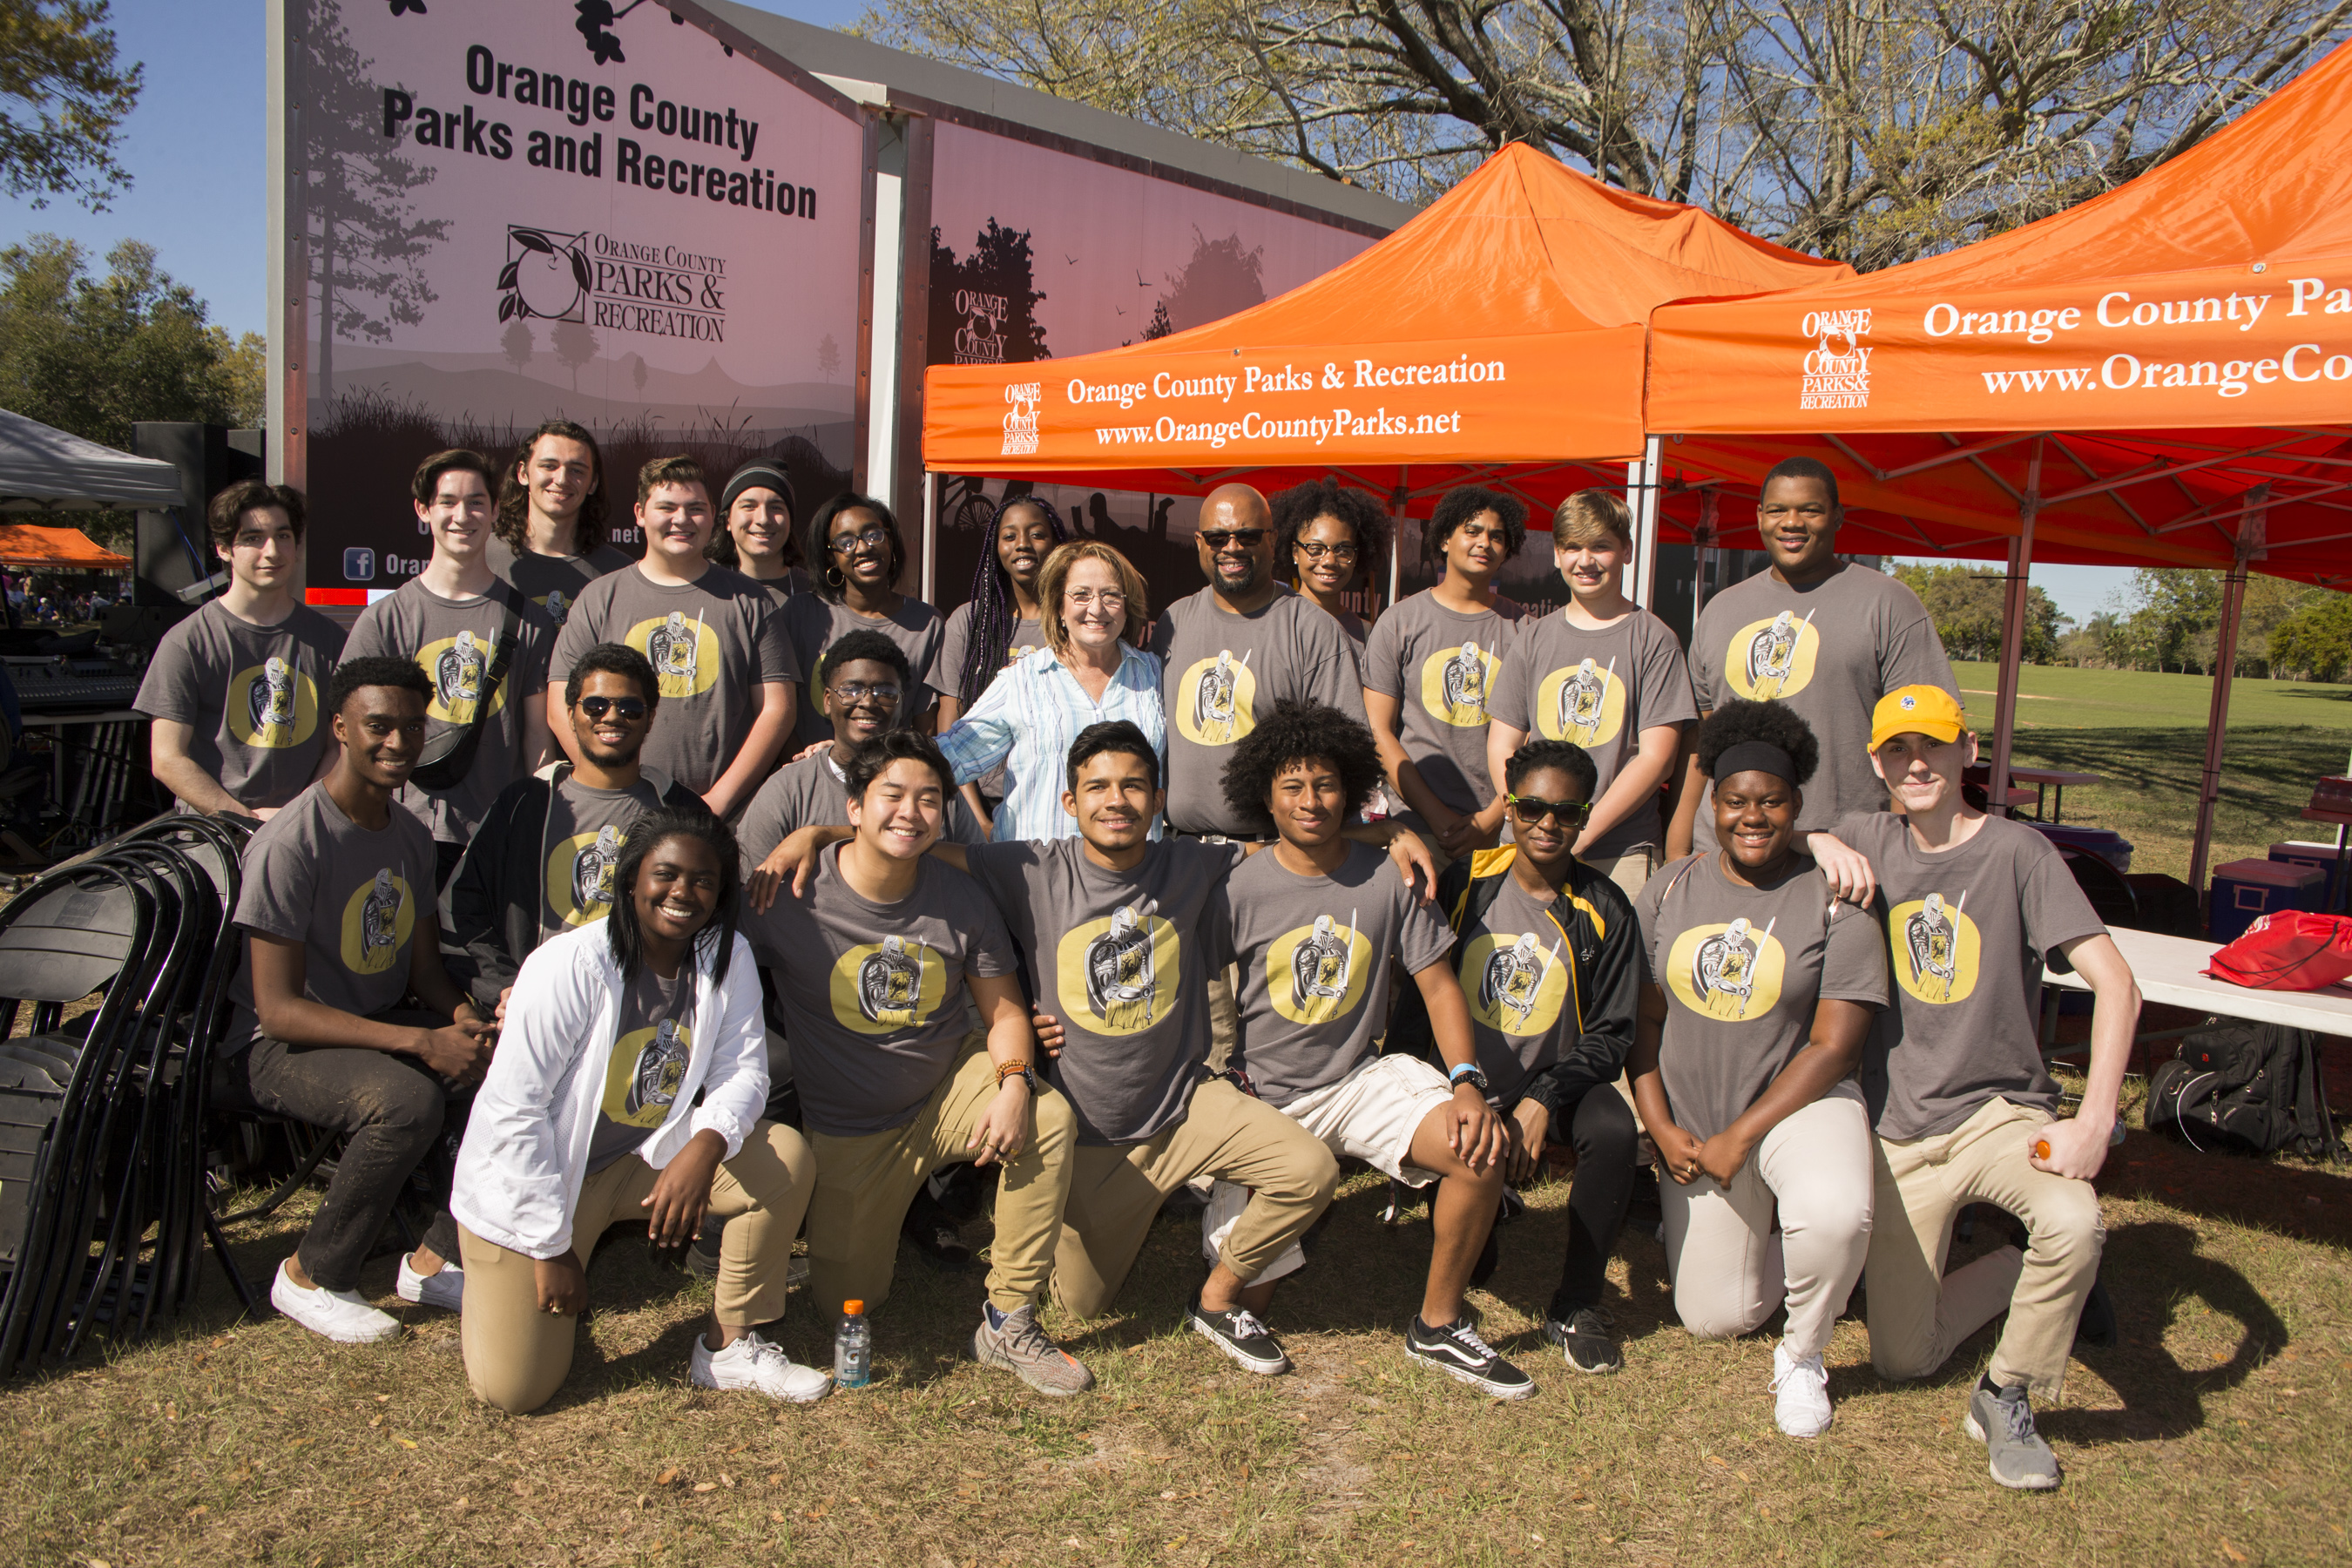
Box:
[212,1009,456,1291]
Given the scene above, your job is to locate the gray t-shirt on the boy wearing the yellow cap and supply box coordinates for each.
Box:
[1832,811,2107,1138]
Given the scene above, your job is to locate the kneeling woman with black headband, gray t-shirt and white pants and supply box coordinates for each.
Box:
[1627,700,1886,1436]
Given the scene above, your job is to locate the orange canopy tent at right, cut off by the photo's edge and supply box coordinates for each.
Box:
[1646,37,2352,879]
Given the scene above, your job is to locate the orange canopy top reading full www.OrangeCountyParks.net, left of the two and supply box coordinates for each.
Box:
[922,145,1851,587]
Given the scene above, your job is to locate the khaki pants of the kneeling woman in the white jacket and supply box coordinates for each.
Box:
[456,1121,816,1416]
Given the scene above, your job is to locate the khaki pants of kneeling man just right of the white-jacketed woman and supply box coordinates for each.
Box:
[809,1034,1078,1321]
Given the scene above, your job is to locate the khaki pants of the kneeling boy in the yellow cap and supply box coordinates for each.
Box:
[1868,1098,2107,1399]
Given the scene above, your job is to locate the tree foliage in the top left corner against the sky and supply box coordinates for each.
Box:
[0,0,144,212]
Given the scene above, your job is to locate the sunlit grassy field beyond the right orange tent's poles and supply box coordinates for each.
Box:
[1952,663,2352,879]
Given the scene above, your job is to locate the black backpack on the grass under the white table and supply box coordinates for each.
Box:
[2147,1023,2345,1161]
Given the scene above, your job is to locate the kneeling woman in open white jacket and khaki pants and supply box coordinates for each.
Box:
[449,811,833,1416]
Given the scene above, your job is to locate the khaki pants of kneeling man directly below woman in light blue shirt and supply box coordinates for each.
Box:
[1054,1079,1338,1316]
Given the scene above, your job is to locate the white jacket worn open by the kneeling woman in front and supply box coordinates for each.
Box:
[449,922,767,1258]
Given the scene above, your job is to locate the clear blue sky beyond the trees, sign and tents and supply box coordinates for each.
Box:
[0,0,2129,620]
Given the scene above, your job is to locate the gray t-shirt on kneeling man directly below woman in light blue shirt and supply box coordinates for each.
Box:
[964,839,1242,1145]
